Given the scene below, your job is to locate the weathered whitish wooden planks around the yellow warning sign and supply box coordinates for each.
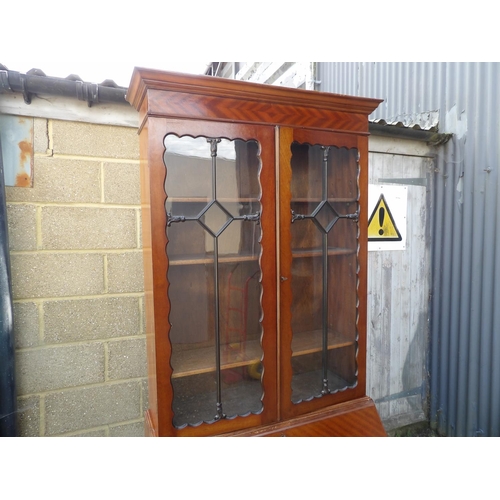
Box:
[367,146,432,428]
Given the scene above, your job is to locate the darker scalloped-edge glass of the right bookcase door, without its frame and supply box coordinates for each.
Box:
[291,143,358,403]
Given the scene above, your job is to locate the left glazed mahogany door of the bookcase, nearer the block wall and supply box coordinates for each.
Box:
[146,120,277,435]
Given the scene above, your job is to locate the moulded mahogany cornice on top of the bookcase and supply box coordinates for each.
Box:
[126,68,382,132]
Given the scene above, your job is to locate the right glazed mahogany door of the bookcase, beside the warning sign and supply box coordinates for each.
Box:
[280,129,365,418]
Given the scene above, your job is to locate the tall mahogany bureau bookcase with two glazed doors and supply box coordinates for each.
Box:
[127,68,385,436]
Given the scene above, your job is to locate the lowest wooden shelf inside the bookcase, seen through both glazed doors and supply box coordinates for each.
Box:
[172,330,354,378]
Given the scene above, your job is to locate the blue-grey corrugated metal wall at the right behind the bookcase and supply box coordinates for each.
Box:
[317,63,500,436]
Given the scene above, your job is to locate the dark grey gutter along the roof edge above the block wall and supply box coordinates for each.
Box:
[0,65,130,107]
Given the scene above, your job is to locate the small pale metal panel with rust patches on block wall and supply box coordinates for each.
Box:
[0,115,33,187]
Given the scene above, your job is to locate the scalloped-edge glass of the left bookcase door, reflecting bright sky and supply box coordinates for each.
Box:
[165,135,262,427]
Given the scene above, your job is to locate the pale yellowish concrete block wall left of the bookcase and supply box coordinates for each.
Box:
[7,118,147,436]
